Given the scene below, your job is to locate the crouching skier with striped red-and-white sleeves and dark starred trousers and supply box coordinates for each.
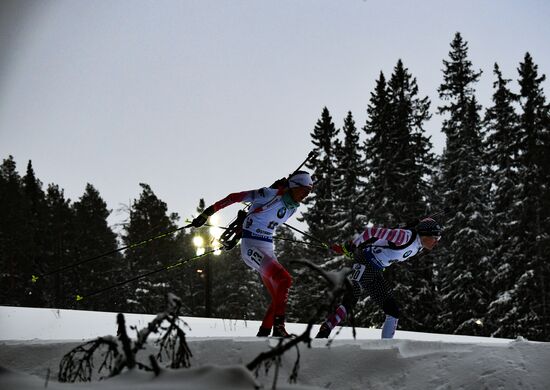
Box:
[315,218,442,338]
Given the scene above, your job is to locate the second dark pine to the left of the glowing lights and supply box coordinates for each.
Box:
[72,183,124,311]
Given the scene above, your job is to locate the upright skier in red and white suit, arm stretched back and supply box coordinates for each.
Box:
[192,171,313,337]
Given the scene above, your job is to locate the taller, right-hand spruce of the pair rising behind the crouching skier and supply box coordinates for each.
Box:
[382,60,436,330]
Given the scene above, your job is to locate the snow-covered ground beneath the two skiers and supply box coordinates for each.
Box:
[0,307,550,390]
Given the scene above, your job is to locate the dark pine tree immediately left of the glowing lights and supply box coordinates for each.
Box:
[121,183,178,313]
